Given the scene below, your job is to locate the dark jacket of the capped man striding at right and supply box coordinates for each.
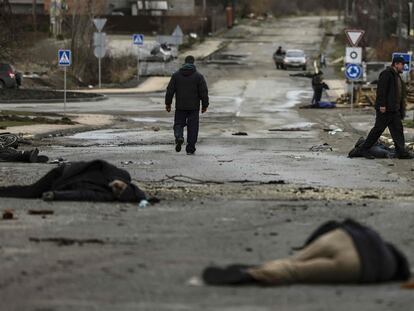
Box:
[375,67,406,117]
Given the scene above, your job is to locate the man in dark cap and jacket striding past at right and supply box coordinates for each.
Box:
[359,57,412,159]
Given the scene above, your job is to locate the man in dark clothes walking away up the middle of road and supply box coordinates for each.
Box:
[165,55,209,155]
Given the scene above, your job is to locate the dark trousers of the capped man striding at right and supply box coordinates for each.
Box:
[361,111,406,155]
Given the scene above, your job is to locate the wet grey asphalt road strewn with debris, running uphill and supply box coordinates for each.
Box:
[0,17,414,311]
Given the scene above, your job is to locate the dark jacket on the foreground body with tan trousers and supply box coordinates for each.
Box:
[305,219,411,283]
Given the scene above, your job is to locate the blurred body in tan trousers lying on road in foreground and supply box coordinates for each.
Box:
[203,219,411,285]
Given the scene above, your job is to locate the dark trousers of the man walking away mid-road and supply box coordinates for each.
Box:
[174,110,200,153]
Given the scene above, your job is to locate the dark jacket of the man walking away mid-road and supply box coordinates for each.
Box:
[165,64,209,110]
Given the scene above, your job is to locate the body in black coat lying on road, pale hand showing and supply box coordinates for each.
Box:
[0,160,145,202]
